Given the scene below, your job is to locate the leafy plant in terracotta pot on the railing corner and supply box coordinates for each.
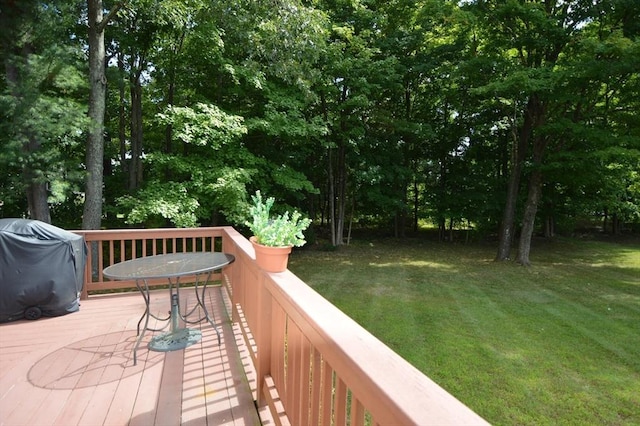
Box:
[245,191,311,272]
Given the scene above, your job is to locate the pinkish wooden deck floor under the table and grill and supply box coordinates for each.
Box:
[0,287,264,426]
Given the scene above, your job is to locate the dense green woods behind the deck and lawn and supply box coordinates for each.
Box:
[0,0,640,264]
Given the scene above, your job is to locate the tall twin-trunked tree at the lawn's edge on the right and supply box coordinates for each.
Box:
[460,1,604,265]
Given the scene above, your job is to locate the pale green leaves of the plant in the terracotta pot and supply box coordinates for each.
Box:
[245,191,311,247]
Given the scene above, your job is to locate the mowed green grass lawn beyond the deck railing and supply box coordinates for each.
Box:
[289,235,640,425]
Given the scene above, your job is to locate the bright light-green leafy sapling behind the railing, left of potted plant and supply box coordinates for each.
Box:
[119,104,250,227]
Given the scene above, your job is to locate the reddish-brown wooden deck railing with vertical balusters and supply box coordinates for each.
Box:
[79,227,487,426]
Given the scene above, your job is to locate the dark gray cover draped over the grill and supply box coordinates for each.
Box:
[0,219,87,322]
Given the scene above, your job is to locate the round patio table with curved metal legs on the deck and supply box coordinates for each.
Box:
[103,252,235,365]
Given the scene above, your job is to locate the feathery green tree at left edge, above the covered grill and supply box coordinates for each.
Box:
[0,1,86,223]
